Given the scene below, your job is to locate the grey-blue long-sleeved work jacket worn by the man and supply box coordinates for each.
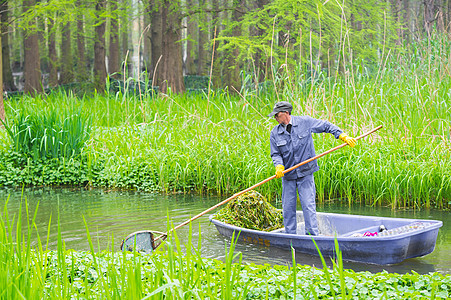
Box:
[269,116,343,180]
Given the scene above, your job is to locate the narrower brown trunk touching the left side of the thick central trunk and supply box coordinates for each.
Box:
[149,0,163,86]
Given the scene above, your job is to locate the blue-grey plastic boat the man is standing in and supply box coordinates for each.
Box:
[210,211,443,265]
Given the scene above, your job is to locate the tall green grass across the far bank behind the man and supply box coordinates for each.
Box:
[0,37,451,208]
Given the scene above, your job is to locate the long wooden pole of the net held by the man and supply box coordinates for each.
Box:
[154,125,382,241]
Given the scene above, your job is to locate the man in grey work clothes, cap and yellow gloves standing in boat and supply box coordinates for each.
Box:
[268,101,357,235]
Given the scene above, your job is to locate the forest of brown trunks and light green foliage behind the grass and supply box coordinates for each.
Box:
[0,0,451,95]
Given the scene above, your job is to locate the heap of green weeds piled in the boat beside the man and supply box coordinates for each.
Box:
[215,191,283,231]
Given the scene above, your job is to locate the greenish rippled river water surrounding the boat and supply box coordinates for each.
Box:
[0,188,451,274]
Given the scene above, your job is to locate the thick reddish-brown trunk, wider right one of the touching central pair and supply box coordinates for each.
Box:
[158,0,185,94]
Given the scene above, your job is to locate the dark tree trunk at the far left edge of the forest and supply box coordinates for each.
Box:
[0,0,17,91]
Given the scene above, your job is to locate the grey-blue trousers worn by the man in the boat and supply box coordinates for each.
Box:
[282,174,319,235]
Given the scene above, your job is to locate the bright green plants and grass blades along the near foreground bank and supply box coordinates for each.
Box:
[0,206,451,299]
